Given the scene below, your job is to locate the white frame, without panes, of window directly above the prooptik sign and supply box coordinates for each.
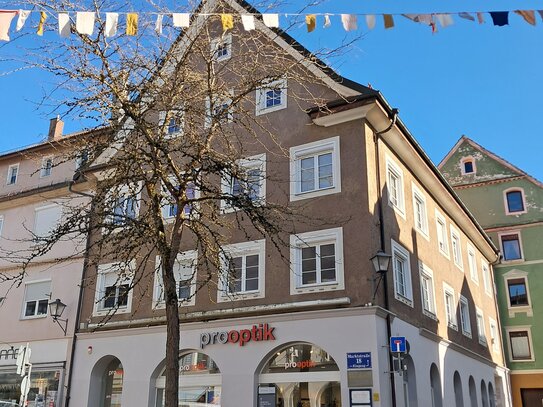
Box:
[217,239,266,302]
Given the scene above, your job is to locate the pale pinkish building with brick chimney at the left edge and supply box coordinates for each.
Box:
[0,119,90,407]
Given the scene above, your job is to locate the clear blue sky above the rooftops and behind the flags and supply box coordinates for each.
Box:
[0,0,543,180]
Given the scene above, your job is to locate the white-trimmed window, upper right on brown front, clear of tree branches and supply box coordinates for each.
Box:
[290,137,341,201]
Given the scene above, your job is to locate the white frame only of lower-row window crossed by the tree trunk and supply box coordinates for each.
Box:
[153,250,198,309]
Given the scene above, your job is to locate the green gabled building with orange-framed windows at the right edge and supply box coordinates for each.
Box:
[439,136,543,407]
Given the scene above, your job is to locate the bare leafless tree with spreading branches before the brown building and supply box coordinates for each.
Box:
[2,0,366,407]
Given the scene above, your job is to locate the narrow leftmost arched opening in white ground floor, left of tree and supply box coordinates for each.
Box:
[87,356,124,407]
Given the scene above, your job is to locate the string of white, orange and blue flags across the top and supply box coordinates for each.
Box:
[0,10,543,41]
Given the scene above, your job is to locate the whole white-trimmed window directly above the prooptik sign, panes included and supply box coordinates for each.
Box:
[219,239,266,301]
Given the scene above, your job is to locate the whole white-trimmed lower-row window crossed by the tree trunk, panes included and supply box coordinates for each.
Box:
[153,250,198,308]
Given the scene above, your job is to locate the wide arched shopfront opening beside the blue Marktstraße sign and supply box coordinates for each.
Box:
[258,343,342,407]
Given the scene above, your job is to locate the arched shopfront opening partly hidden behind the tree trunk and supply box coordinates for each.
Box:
[155,351,221,407]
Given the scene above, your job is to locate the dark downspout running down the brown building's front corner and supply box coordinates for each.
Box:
[373,109,398,407]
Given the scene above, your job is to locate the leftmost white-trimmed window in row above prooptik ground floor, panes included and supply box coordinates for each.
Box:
[94,261,135,315]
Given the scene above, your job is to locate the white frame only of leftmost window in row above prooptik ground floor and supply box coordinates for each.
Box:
[92,260,136,316]
